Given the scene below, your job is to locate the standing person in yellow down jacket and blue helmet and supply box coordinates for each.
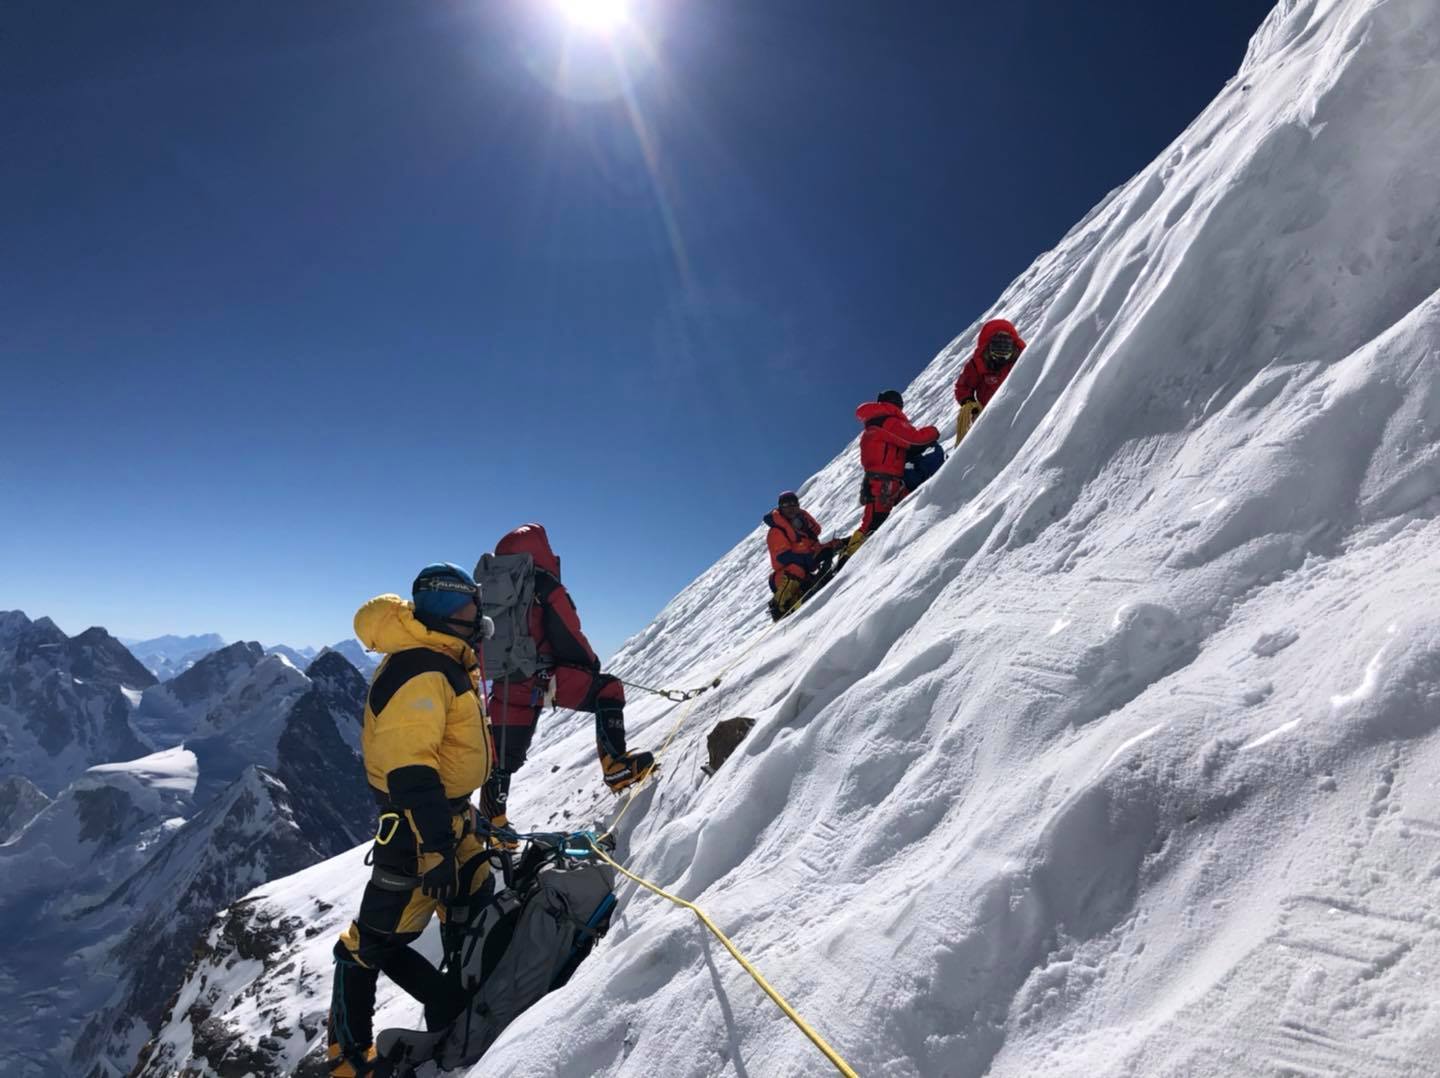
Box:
[327,563,494,1078]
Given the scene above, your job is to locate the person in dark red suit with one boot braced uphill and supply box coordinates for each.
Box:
[482,524,655,826]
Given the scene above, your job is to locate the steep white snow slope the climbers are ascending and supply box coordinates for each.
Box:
[144,0,1440,1078]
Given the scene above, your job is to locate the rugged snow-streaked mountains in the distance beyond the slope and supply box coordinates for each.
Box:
[0,612,374,1078]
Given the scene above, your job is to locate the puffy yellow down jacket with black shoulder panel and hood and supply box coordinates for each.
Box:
[356,594,492,797]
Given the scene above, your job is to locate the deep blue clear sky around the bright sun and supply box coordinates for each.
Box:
[0,0,1270,652]
